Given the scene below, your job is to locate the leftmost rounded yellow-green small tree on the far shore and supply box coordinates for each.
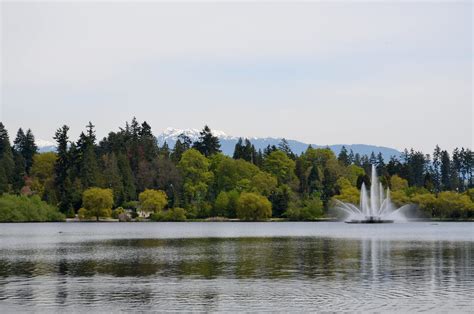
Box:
[82,188,114,220]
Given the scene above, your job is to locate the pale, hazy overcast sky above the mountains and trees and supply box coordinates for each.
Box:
[0,1,474,153]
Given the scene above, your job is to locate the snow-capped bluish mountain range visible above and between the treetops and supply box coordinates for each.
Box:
[36,128,401,161]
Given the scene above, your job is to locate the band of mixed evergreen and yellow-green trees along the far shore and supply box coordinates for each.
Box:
[0,118,474,222]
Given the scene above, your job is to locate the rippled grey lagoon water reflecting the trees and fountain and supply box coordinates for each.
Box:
[0,222,474,313]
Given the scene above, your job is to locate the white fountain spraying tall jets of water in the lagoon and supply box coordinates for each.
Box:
[336,165,410,223]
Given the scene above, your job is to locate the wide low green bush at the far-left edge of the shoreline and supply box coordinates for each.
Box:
[0,194,65,222]
